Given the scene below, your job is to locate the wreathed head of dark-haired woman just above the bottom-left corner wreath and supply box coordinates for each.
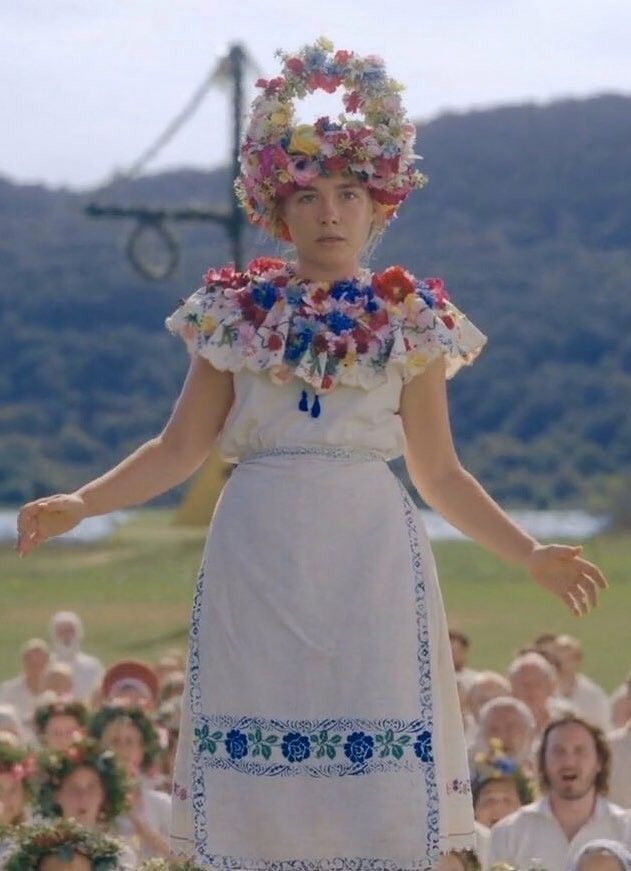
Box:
[35,738,137,867]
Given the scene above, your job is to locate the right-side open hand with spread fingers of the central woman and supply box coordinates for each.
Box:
[526,544,609,617]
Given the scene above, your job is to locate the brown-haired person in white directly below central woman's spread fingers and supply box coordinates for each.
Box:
[554,635,611,732]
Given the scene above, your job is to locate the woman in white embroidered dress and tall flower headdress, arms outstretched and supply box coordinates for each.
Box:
[17,39,606,871]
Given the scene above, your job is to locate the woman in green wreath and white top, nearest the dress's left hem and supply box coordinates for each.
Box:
[90,704,171,859]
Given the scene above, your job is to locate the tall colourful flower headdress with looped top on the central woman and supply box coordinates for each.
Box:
[235,37,427,238]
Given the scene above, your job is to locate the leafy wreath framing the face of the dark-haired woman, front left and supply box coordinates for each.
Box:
[36,738,130,822]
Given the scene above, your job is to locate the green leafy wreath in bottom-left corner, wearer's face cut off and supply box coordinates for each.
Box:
[3,820,123,871]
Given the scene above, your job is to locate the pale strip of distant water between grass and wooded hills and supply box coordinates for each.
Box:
[0,509,609,544]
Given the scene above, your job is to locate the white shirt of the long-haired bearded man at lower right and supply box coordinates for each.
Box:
[488,796,631,871]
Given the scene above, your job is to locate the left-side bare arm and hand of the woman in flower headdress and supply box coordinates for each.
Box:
[16,356,234,556]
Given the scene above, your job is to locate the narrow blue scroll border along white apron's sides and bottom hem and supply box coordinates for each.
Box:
[189,480,440,871]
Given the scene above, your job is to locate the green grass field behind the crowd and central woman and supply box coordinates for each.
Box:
[0,510,631,690]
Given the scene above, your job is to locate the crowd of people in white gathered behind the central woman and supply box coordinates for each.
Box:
[0,611,631,871]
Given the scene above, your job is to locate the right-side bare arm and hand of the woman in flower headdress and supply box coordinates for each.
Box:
[399,355,607,613]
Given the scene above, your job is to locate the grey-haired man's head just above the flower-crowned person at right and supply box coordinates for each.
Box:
[475,696,536,774]
